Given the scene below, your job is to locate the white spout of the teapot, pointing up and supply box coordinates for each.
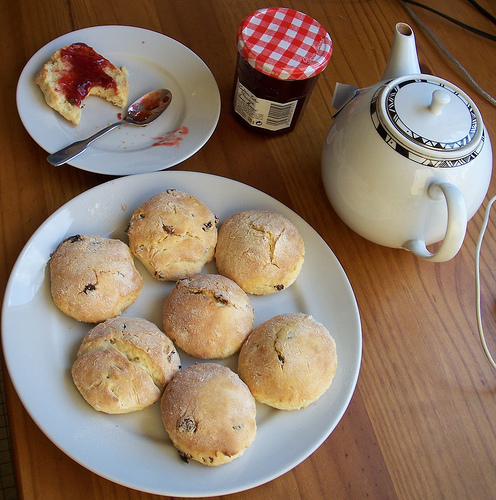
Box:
[382,23,421,80]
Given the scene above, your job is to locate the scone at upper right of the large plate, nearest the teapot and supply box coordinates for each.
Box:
[215,210,305,295]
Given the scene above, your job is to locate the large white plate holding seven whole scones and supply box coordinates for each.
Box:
[2,171,362,497]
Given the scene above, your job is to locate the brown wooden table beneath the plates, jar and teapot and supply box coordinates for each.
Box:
[0,0,496,500]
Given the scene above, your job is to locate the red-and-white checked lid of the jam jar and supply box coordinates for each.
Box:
[238,7,332,80]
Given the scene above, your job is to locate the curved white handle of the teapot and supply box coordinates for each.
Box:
[403,182,467,262]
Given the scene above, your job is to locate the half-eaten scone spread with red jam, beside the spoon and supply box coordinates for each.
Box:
[35,43,129,125]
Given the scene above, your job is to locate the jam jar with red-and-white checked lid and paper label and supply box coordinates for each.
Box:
[233,8,332,135]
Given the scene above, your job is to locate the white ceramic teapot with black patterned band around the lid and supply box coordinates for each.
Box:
[322,23,492,262]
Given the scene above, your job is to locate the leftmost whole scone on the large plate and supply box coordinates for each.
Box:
[49,234,143,323]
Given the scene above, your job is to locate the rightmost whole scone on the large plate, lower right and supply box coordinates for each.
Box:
[238,313,337,410]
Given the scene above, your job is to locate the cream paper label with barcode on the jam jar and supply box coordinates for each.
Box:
[234,80,298,131]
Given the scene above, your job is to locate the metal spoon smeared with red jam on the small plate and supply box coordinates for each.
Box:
[47,89,172,167]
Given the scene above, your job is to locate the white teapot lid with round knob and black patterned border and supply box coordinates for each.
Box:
[371,75,484,167]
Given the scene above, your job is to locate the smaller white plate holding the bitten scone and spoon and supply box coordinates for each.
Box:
[17,26,220,175]
